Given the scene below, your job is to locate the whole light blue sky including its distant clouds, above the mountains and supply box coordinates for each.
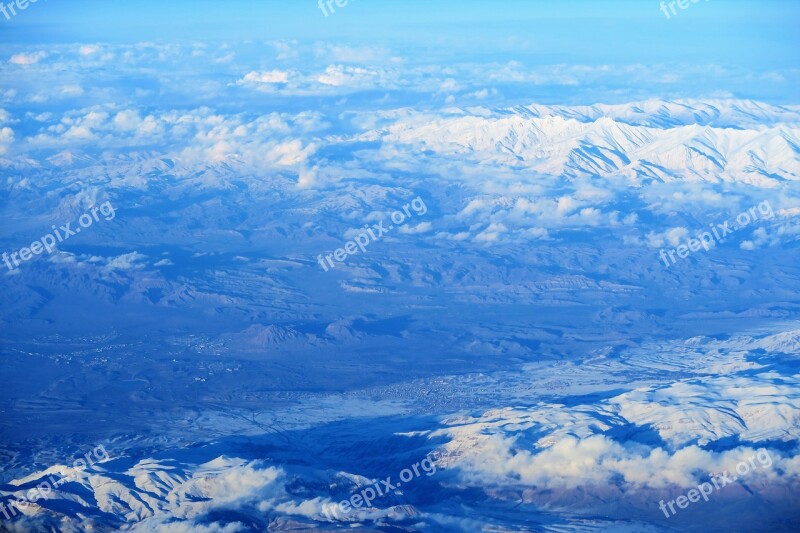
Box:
[0,0,800,112]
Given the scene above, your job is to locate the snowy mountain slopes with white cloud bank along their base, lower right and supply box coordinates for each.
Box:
[435,374,800,490]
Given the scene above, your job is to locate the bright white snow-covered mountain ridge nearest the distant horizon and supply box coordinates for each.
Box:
[382,102,800,187]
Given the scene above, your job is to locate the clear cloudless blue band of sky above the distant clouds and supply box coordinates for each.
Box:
[0,0,800,68]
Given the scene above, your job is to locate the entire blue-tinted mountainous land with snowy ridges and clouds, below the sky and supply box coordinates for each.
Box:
[0,88,800,532]
